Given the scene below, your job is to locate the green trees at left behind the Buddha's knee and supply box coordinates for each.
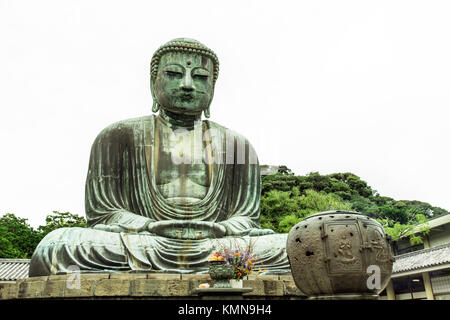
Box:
[0,211,86,259]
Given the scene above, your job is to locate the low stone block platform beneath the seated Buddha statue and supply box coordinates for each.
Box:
[0,273,304,300]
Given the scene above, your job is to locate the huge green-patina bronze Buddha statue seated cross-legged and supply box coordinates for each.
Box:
[29,38,290,277]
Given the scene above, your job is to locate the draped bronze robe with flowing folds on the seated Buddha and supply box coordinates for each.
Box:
[30,115,290,276]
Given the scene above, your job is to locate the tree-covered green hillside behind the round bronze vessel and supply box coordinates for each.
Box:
[261,166,449,243]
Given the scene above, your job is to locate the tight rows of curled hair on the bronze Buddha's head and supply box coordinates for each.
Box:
[150,38,219,84]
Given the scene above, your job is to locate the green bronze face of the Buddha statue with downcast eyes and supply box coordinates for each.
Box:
[153,52,214,115]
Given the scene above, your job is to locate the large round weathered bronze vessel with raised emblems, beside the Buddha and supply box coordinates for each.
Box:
[287,211,394,299]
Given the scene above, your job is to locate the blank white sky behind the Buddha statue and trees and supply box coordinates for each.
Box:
[0,0,450,226]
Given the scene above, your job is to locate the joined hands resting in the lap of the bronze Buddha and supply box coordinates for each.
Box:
[147,220,226,240]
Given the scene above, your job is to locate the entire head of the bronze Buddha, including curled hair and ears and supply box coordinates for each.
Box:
[150,38,219,117]
